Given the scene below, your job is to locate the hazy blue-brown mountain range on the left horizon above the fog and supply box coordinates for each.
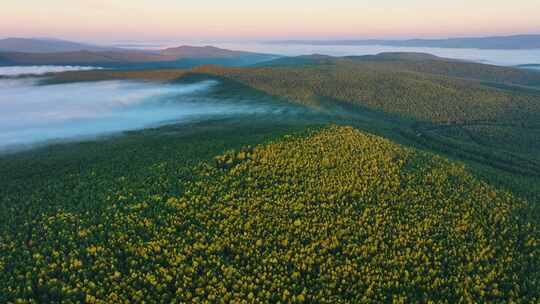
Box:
[0,38,279,68]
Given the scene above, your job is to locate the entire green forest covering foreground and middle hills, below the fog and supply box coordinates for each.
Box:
[0,54,540,303]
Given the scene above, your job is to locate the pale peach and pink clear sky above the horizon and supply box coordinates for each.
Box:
[0,0,540,42]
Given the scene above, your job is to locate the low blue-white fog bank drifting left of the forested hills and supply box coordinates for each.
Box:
[0,78,292,150]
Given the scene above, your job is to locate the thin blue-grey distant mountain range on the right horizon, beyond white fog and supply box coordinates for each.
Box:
[269,35,540,50]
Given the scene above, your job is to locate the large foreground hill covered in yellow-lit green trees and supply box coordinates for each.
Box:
[0,126,540,303]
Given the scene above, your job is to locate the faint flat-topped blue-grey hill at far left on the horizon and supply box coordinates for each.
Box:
[0,38,114,53]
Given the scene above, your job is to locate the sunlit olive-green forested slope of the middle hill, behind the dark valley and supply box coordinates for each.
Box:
[195,60,540,124]
